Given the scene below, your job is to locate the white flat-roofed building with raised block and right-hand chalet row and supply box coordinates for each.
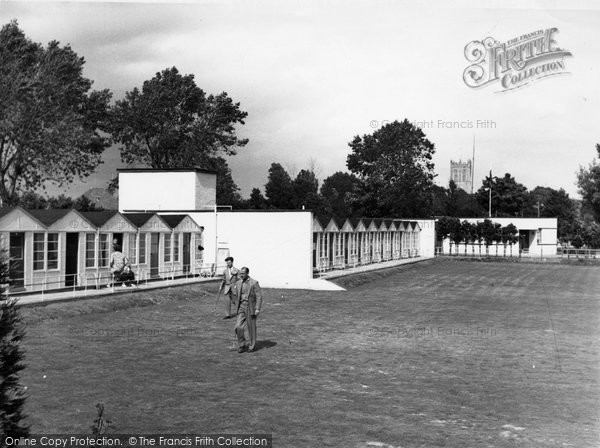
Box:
[119,169,435,289]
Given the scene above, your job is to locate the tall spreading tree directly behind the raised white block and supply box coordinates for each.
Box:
[112,67,248,204]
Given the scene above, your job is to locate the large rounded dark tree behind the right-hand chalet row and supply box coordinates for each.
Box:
[346,120,435,218]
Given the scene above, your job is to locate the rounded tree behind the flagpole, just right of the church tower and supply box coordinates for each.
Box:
[476,173,528,216]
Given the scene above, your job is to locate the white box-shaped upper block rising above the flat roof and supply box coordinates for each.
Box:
[119,170,216,212]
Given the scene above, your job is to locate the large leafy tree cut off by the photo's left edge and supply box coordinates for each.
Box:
[0,21,111,204]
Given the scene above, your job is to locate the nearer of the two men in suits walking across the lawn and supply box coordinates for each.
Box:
[235,267,262,353]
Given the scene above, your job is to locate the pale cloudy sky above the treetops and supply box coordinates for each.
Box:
[0,0,600,198]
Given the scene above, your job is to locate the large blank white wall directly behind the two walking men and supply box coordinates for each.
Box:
[188,211,314,289]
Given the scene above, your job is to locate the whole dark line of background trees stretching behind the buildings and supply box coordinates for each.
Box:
[0,21,600,247]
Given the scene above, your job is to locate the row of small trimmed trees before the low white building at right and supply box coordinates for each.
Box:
[436,216,519,256]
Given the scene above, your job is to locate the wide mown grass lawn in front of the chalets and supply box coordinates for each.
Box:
[16,260,600,448]
